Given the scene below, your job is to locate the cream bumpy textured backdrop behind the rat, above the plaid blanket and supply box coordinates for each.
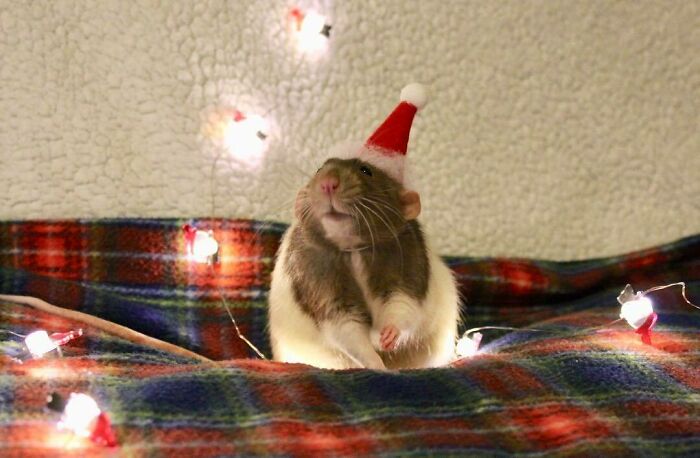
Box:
[0,0,700,259]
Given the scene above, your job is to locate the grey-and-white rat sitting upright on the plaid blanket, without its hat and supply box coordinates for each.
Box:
[269,157,459,370]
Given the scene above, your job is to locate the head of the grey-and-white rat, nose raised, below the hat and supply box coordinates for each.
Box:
[295,158,421,249]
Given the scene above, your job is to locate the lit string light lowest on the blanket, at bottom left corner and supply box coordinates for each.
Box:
[46,393,117,447]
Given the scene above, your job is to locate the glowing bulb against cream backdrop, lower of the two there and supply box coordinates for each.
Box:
[224,115,268,165]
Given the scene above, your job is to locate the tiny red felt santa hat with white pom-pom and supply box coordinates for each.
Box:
[358,83,426,183]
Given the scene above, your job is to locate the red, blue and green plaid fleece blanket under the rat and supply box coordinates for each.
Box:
[0,219,700,457]
